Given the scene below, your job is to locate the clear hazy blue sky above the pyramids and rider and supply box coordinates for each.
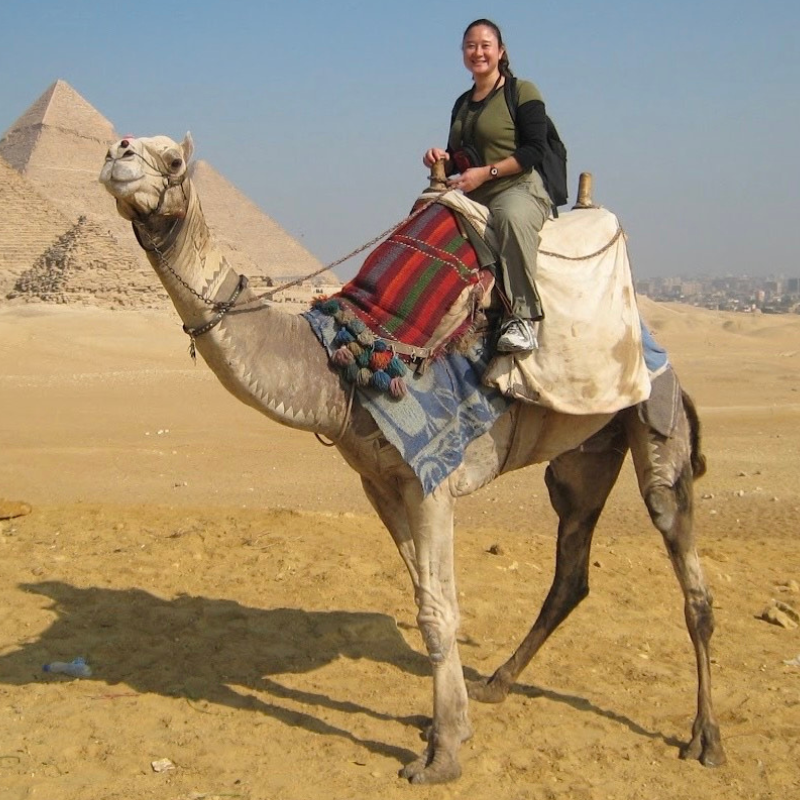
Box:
[0,0,800,278]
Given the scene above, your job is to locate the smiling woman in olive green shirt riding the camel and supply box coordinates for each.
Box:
[422,19,552,353]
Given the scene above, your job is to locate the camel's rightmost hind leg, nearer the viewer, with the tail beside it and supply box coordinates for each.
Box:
[625,395,725,766]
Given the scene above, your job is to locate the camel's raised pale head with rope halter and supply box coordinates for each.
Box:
[100,133,194,220]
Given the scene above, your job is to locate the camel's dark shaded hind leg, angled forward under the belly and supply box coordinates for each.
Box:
[467,418,627,703]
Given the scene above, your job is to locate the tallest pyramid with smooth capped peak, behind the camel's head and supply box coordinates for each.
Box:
[0,80,332,306]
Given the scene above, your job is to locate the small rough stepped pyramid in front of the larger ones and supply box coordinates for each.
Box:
[8,217,168,308]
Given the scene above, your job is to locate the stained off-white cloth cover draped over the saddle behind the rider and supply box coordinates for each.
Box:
[434,192,650,414]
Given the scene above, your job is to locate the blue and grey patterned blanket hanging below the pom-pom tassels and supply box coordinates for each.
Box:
[303,310,511,494]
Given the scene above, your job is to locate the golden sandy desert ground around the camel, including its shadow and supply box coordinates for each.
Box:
[0,301,800,800]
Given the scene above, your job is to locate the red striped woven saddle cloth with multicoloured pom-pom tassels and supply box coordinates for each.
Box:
[313,201,494,397]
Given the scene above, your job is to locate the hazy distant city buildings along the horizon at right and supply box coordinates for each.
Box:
[634,275,800,314]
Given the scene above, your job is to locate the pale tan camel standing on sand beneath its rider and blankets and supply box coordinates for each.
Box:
[100,134,725,784]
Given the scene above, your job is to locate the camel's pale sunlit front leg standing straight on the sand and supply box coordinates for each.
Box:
[400,481,472,783]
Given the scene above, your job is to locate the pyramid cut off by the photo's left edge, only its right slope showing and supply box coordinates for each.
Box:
[0,158,70,298]
